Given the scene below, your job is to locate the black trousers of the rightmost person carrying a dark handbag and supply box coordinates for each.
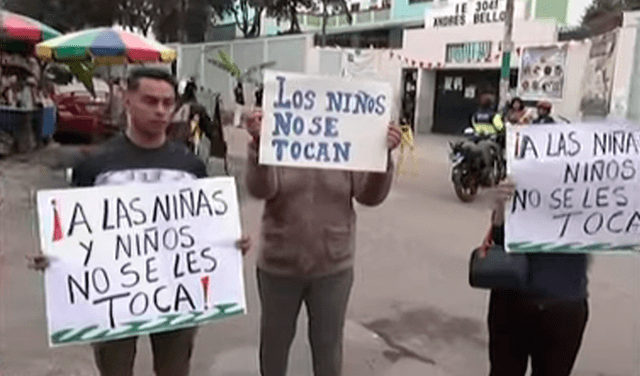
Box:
[489,291,589,376]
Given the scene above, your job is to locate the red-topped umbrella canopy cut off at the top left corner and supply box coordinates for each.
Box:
[0,10,61,44]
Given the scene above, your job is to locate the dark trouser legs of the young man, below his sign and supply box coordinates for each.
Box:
[93,328,196,376]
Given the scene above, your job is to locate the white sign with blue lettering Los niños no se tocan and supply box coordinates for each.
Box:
[260,71,392,172]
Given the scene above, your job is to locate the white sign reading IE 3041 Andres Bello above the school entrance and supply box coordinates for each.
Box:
[425,0,507,27]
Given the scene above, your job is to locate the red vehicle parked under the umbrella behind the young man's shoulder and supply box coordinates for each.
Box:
[53,79,119,143]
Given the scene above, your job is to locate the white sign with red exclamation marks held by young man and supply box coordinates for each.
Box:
[38,178,246,346]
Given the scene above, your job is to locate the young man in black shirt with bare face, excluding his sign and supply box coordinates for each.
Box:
[30,68,250,376]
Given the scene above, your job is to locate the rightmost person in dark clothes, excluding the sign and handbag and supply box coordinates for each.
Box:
[483,180,589,376]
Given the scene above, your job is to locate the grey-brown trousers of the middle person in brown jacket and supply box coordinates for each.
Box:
[258,269,353,376]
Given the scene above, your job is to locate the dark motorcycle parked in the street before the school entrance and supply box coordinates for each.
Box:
[449,128,507,202]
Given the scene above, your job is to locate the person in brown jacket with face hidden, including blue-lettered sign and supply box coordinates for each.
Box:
[246,72,401,376]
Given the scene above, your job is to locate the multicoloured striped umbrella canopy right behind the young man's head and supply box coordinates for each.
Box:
[36,28,176,65]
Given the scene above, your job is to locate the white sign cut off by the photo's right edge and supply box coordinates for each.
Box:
[505,124,640,253]
